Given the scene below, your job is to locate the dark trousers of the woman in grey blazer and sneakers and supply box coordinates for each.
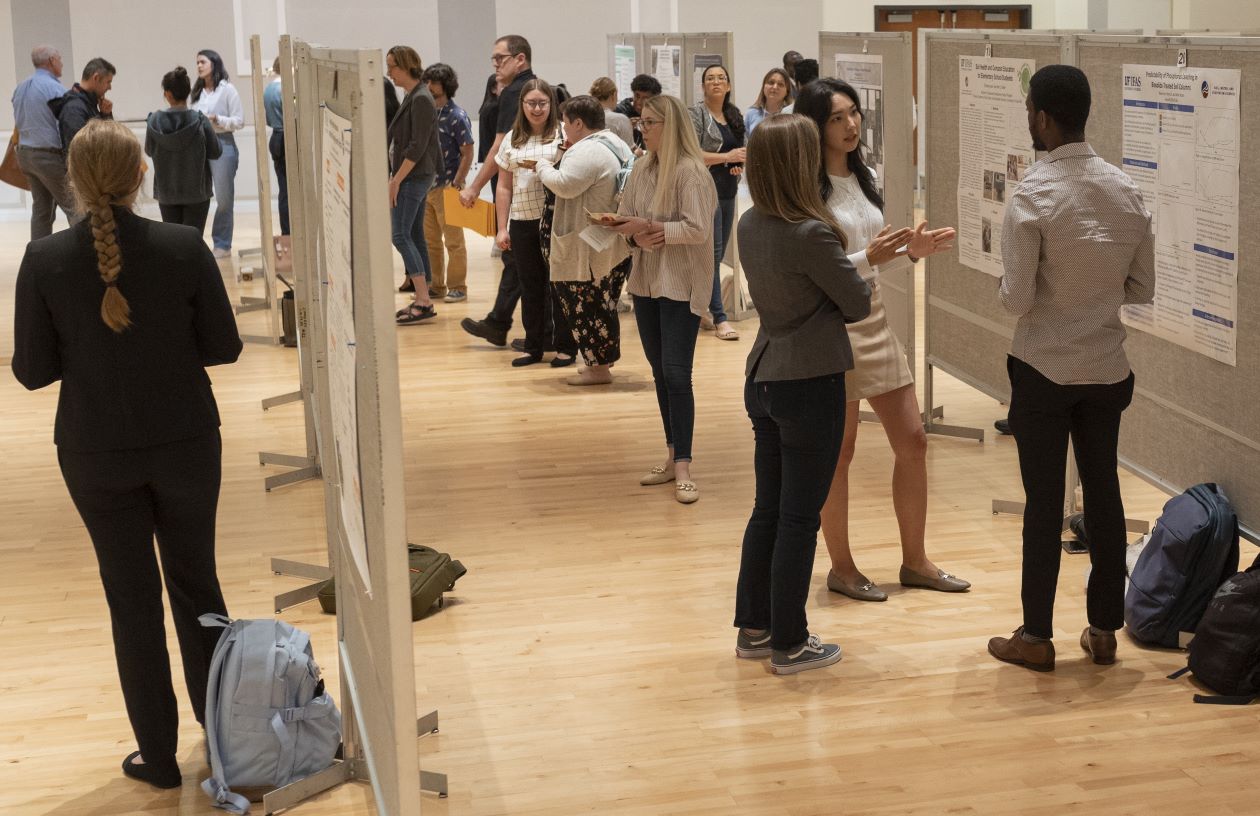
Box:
[735,374,844,650]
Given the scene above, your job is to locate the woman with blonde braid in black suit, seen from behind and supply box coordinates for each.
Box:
[13,120,241,788]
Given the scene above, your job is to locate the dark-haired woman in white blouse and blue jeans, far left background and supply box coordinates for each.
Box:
[193,48,244,258]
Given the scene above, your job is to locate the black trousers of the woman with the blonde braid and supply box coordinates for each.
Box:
[57,431,227,762]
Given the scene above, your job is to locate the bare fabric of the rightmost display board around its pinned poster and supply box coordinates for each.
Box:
[1076,35,1260,531]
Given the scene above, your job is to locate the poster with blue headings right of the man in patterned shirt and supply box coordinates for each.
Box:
[1123,65,1242,365]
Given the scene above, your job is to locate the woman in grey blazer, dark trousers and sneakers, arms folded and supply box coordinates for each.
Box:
[735,116,871,674]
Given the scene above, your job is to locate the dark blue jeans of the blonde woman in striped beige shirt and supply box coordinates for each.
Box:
[634,295,701,462]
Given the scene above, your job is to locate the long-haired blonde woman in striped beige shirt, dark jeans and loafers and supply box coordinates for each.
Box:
[616,96,715,504]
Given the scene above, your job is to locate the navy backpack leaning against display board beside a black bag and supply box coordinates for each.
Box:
[1124,484,1239,649]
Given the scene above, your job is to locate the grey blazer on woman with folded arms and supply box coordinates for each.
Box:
[738,208,871,383]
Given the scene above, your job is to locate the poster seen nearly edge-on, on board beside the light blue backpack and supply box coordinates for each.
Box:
[321,107,372,587]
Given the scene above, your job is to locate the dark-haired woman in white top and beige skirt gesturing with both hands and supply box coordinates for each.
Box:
[795,78,971,601]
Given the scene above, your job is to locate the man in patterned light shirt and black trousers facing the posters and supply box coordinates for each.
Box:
[989,65,1155,671]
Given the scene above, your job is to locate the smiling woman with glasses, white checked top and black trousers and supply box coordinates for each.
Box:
[494,78,577,368]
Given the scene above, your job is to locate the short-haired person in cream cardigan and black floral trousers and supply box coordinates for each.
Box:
[538,96,634,385]
